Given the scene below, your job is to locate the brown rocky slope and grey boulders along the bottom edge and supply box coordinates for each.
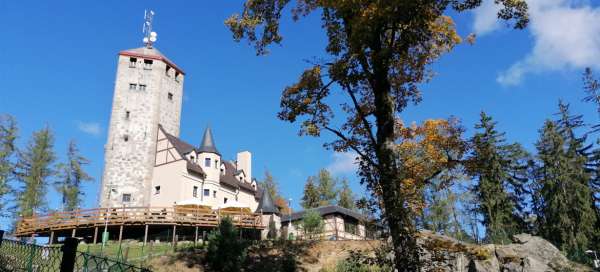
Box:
[144,232,592,272]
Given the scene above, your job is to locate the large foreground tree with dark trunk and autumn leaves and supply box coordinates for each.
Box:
[225,0,529,266]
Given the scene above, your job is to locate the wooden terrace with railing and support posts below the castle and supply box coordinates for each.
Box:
[15,206,265,243]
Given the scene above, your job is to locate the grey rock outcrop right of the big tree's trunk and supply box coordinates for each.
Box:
[419,232,592,272]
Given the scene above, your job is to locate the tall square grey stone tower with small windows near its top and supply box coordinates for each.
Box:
[99,37,184,207]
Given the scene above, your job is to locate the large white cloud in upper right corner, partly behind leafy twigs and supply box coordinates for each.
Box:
[473,0,600,85]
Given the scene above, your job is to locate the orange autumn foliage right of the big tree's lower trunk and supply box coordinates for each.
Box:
[396,119,466,213]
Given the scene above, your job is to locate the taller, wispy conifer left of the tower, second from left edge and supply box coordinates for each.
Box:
[16,127,56,216]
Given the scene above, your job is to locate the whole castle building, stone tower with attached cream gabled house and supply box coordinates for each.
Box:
[99,30,260,211]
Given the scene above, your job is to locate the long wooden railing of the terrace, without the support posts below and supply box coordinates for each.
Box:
[15,207,264,236]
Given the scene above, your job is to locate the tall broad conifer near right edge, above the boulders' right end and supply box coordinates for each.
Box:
[534,102,596,260]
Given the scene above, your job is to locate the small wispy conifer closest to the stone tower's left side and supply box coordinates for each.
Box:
[56,140,93,211]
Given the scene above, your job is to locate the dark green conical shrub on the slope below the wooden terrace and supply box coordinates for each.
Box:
[206,217,247,272]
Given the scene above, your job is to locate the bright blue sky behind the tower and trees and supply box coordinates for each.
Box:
[0,0,600,227]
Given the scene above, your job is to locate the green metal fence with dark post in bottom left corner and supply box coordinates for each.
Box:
[0,230,150,272]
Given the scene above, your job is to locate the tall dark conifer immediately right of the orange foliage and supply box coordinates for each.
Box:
[467,112,526,243]
